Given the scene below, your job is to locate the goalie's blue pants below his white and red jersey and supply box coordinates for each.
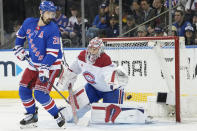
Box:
[85,83,124,104]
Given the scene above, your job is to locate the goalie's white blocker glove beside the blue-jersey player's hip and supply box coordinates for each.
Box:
[58,66,77,90]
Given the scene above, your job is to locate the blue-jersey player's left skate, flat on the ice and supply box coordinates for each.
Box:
[20,107,38,129]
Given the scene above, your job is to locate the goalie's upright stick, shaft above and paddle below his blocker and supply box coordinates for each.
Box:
[60,38,79,124]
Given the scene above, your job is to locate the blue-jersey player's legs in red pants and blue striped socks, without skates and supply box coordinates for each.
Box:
[19,68,60,116]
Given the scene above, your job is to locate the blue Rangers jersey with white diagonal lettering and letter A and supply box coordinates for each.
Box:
[15,18,62,70]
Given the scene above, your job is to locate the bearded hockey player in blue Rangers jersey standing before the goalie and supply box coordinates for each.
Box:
[14,1,65,127]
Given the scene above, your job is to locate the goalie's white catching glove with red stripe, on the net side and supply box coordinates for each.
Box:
[105,66,128,90]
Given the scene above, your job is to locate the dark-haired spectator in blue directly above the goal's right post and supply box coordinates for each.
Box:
[173,10,191,36]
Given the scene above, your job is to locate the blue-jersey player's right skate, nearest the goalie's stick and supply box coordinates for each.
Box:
[55,107,66,127]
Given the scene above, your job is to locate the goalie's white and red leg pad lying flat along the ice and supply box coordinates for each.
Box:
[91,103,146,123]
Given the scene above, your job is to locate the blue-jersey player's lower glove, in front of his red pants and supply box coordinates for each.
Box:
[39,65,49,83]
